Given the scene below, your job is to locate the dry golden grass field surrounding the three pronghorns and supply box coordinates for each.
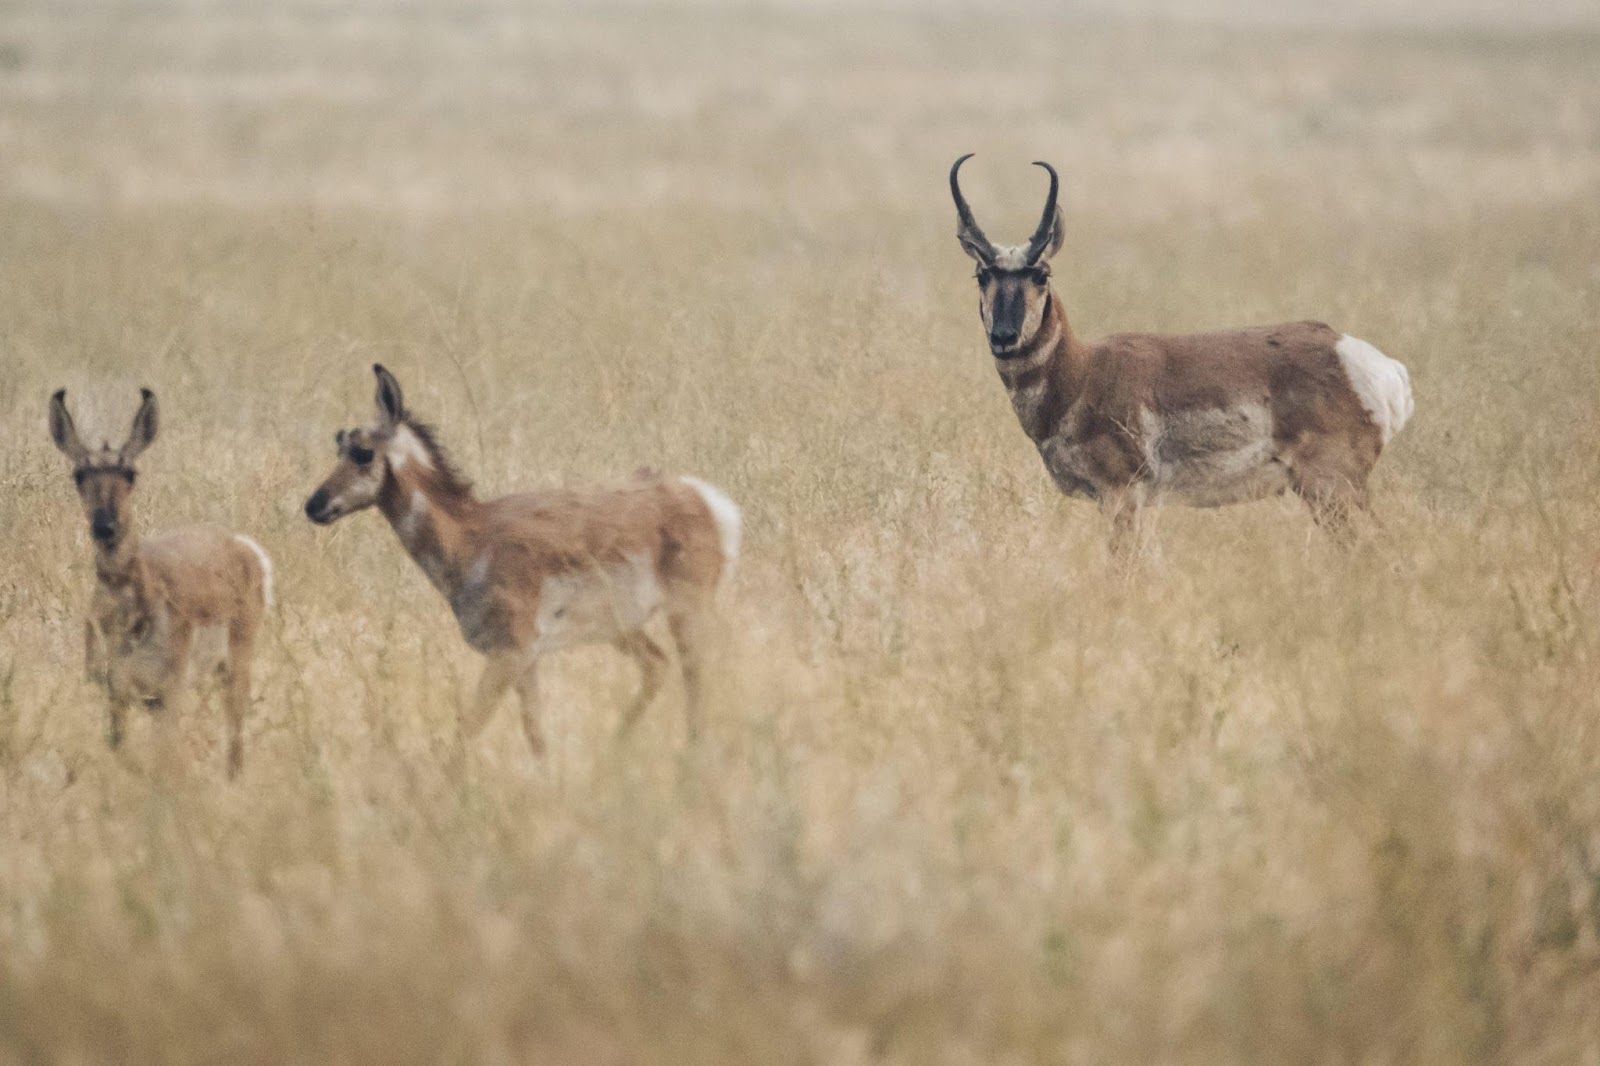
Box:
[0,0,1600,1066]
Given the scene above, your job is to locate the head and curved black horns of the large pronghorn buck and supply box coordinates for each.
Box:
[950,152,1061,359]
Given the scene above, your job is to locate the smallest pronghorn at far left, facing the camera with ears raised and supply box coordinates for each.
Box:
[50,389,272,778]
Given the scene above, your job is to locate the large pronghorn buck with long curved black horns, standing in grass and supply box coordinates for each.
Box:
[950,154,1411,551]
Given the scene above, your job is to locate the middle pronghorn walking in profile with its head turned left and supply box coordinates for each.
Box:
[306,365,741,755]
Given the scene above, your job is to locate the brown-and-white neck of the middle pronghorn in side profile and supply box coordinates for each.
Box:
[378,463,483,597]
